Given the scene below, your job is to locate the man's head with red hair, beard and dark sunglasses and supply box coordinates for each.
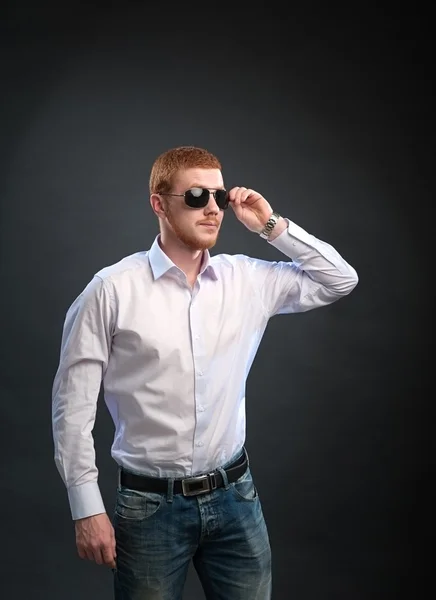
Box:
[150,146,224,250]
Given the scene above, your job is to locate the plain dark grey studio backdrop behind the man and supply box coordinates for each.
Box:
[0,0,434,600]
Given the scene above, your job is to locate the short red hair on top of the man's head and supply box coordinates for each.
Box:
[149,146,221,194]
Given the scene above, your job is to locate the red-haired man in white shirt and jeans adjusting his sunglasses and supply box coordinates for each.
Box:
[53,147,358,600]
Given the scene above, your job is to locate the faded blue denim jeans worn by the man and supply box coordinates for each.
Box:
[113,450,272,600]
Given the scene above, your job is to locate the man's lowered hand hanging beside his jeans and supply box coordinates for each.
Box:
[75,513,116,569]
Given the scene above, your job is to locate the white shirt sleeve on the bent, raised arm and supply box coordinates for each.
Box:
[248,219,358,317]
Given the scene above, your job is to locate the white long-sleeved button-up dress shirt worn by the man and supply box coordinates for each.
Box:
[52,219,358,519]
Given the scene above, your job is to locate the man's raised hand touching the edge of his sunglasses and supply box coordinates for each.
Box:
[229,187,273,233]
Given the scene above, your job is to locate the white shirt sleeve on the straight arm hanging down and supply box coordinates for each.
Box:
[52,276,114,519]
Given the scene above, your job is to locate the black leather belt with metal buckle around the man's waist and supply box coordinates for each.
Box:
[120,448,248,496]
